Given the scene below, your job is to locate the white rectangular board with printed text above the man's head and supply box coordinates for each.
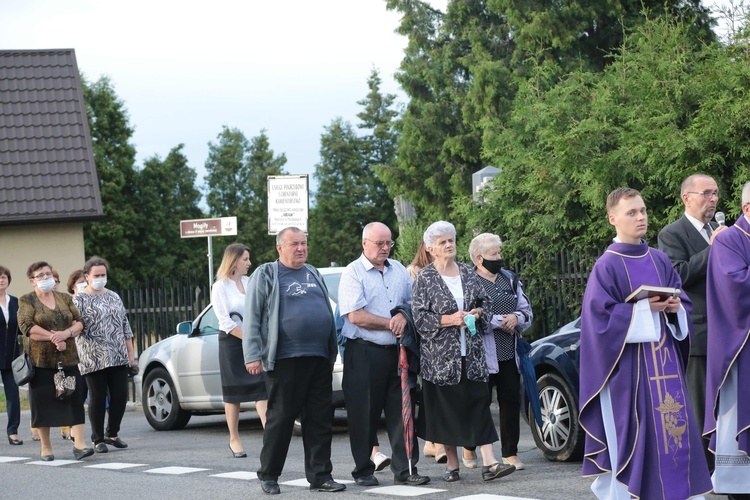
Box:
[268,174,310,235]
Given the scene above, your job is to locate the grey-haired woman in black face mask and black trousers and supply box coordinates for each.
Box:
[464,233,534,470]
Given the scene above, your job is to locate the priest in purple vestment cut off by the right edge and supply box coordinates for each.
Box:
[704,182,750,494]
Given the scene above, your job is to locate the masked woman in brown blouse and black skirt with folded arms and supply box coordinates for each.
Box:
[18,262,94,461]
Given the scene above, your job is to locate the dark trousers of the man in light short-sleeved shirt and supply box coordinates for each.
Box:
[343,340,419,479]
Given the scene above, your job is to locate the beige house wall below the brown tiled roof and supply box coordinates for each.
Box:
[0,222,86,297]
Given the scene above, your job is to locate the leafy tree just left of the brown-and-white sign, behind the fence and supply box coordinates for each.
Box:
[133,144,205,280]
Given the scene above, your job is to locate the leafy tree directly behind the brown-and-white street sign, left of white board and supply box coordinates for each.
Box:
[206,127,286,268]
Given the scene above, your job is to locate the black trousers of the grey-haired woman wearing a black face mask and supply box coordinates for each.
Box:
[489,359,521,457]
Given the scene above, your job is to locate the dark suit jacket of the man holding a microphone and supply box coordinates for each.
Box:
[659,215,717,356]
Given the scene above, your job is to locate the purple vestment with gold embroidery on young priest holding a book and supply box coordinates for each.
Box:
[580,242,712,500]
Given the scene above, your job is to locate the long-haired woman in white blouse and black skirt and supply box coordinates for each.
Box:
[211,243,268,458]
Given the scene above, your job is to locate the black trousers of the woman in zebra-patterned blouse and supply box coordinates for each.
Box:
[86,365,128,444]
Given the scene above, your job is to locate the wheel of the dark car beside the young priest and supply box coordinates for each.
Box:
[529,373,584,462]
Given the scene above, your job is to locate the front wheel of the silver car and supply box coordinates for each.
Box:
[143,368,191,431]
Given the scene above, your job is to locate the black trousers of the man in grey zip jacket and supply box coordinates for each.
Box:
[258,356,333,486]
